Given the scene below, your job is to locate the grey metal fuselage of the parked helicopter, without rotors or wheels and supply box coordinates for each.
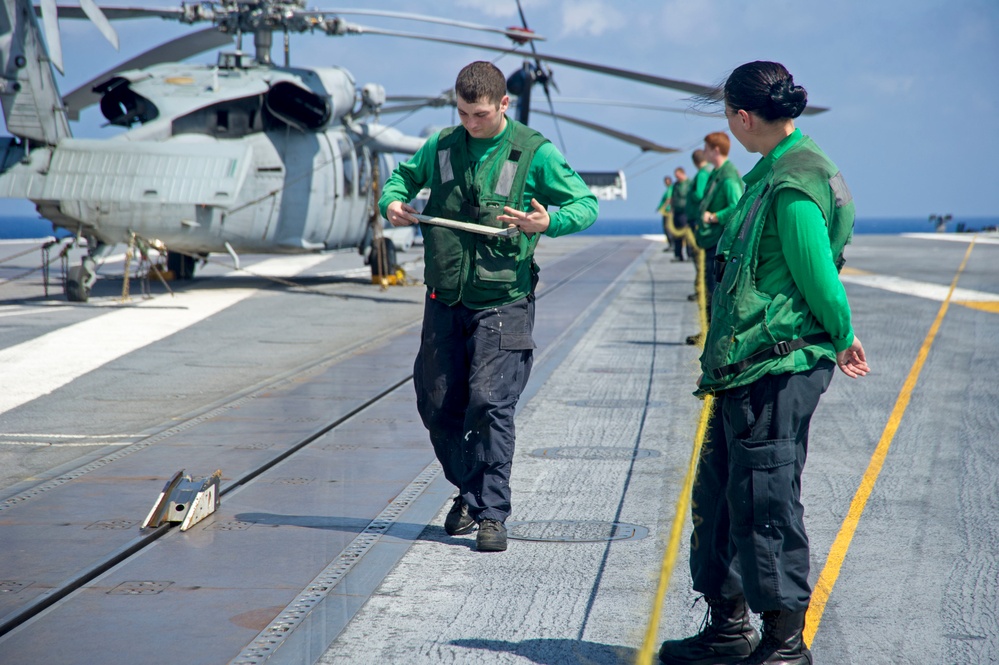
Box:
[10,57,390,254]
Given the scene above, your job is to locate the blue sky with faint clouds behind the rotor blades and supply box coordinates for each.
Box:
[0,0,999,221]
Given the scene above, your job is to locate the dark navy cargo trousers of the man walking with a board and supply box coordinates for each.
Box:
[413,296,534,522]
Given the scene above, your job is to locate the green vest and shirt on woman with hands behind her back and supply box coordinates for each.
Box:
[697,130,854,394]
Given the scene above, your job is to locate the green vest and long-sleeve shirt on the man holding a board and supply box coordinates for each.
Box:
[379,118,597,309]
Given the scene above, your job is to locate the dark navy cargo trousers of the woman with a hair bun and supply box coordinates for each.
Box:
[690,360,834,612]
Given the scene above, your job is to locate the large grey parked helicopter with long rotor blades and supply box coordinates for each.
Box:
[0,0,828,302]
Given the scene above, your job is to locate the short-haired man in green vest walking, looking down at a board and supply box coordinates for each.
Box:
[378,62,597,552]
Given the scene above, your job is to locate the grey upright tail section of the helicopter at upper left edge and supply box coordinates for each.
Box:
[0,0,70,145]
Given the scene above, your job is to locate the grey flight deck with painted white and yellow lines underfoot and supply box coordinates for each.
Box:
[0,234,999,665]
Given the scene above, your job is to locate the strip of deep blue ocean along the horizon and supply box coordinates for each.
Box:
[0,216,999,240]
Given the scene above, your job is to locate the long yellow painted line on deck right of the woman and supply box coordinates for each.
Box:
[804,238,975,644]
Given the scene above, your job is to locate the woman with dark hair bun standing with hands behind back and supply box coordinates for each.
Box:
[659,62,869,665]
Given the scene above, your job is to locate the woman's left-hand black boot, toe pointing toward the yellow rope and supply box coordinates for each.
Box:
[659,596,760,665]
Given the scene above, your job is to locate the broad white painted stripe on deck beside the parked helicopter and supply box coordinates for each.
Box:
[0,255,327,413]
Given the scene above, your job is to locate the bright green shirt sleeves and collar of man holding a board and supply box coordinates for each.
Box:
[378,122,599,238]
